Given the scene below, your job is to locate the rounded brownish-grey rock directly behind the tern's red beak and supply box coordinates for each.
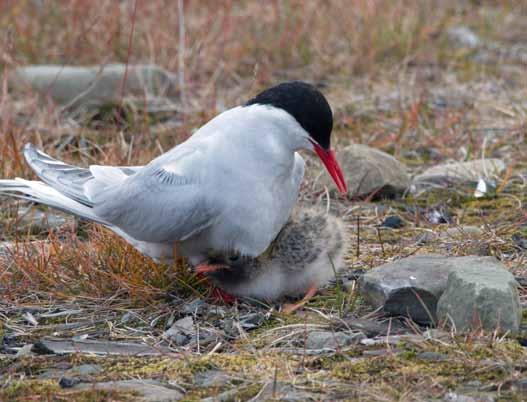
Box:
[308,144,410,197]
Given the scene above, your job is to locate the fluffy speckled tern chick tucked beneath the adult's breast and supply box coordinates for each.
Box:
[200,207,348,304]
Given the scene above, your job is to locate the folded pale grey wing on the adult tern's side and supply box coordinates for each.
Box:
[93,147,219,243]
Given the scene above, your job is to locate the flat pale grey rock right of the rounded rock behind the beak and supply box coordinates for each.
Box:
[413,159,506,188]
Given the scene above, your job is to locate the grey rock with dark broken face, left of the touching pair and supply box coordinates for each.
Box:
[359,254,455,323]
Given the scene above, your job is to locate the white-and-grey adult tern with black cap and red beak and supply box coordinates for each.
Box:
[0,81,347,266]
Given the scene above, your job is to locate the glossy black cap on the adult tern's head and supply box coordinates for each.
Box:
[245,81,333,149]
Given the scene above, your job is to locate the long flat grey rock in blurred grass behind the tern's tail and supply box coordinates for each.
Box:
[9,64,177,111]
